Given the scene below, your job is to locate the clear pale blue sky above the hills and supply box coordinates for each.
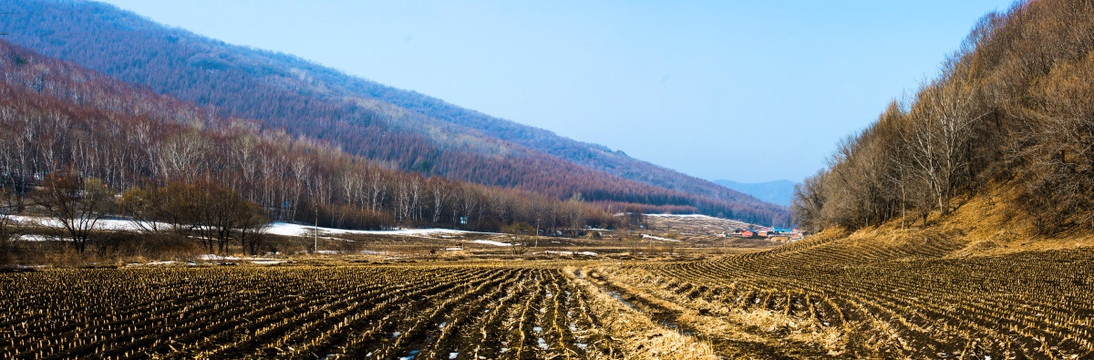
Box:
[98,0,1011,182]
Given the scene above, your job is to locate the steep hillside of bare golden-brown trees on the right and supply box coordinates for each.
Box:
[793,0,1094,235]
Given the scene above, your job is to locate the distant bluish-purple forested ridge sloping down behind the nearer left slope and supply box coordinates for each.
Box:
[0,1,789,224]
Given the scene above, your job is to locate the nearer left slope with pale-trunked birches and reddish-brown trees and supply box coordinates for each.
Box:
[0,42,620,235]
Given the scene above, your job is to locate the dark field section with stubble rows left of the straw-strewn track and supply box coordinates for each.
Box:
[0,266,621,359]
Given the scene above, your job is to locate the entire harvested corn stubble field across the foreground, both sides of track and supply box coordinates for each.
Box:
[0,240,1094,359]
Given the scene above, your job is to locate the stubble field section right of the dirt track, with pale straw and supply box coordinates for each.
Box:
[600,235,1094,359]
